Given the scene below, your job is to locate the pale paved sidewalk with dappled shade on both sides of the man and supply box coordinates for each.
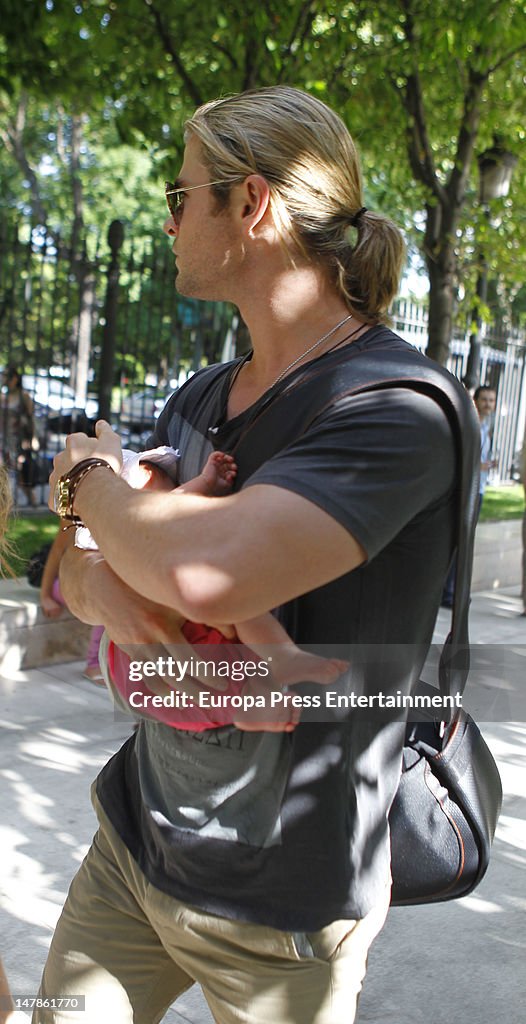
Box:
[0,588,526,1024]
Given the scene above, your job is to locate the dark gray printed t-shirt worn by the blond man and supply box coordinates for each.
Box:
[97,330,454,931]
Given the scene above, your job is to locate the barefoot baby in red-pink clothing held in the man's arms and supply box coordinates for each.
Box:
[76,446,348,732]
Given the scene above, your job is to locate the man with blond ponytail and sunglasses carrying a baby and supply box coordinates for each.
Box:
[34,87,469,1024]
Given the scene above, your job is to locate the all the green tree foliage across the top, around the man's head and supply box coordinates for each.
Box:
[0,0,526,361]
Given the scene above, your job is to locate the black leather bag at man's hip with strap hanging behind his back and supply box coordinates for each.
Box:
[389,360,502,906]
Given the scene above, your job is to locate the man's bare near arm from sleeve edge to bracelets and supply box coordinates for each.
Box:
[67,469,365,623]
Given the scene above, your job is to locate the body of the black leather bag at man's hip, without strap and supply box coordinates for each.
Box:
[389,683,502,906]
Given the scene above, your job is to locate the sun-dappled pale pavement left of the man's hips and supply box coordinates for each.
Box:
[0,666,129,947]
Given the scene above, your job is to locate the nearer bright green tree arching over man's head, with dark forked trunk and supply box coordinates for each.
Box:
[66,0,526,362]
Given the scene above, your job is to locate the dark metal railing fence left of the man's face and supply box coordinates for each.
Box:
[0,221,237,409]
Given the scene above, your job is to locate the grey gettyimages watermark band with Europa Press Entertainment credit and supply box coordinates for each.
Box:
[99,643,526,729]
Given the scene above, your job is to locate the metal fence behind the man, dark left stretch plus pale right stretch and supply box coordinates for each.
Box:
[0,221,526,506]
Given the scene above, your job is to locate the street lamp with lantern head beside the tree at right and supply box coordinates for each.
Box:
[464,135,517,388]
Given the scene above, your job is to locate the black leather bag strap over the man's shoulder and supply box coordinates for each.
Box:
[229,344,480,695]
